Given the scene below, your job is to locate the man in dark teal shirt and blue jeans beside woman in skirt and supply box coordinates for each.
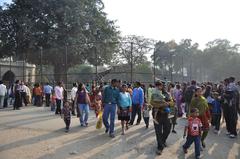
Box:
[102,79,120,138]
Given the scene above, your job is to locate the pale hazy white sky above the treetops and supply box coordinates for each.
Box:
[103,0,240,47]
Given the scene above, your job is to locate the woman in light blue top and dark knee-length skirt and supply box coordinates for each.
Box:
[118,84,132,135]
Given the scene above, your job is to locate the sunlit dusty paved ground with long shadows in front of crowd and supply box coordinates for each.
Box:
[0,106,240,159]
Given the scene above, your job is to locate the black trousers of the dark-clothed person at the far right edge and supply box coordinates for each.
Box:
[223,104,238,135]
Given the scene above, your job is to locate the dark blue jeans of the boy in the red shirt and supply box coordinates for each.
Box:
[183,135,200,158]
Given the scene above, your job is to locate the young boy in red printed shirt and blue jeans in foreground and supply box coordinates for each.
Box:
[183,108,202,159]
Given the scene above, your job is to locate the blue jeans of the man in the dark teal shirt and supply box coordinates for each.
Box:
[103,104,117,134]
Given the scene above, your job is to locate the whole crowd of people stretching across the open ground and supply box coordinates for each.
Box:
[0,77,240,158]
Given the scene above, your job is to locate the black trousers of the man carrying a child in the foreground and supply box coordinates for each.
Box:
[154,115,171,150]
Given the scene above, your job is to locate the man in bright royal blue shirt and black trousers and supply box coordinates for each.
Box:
[130,82,144,125]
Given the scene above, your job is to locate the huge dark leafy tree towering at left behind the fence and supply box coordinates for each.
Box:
[0,0,118,80]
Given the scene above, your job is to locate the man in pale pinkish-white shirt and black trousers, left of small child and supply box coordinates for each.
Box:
[54,82,63,114]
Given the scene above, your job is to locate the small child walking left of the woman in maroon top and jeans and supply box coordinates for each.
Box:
[61,101,71,132]
